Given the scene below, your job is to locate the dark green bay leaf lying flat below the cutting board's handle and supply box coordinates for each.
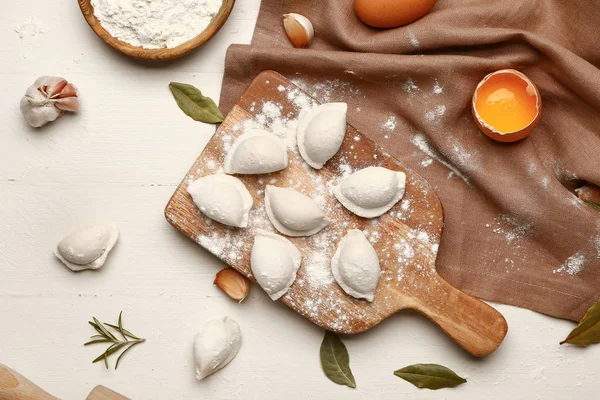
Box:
[394,364,467,390]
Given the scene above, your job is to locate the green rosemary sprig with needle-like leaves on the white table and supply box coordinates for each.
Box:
[83,311,146,369]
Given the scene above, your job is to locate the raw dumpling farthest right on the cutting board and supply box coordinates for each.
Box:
[333,167,406,218]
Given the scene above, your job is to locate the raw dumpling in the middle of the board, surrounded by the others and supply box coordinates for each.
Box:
[265,185,329,236]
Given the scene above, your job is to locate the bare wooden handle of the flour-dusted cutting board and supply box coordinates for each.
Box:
[413,274,508,357]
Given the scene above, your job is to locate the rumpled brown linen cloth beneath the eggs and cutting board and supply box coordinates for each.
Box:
[221,0,600,320]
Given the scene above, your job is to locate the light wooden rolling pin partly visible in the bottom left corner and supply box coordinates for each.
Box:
[0,364,130,400]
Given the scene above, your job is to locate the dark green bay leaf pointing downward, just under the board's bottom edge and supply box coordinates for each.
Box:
[320,331,356,388]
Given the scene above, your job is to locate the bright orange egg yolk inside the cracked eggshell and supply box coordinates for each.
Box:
[475,74,538,133]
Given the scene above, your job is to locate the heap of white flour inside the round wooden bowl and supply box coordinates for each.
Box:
[92,0,223,49]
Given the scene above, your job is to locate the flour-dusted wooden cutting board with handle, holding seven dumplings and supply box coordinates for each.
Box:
[165,71,507,356]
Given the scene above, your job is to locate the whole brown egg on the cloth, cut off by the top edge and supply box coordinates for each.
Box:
[354,0,437,28]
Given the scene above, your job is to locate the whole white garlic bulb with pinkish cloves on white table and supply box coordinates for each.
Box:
[21,76,79,128]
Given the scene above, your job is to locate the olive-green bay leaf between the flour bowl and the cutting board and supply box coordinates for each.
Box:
[169,82,224,124]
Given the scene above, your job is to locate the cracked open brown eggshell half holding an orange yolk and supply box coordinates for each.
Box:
[471,69,542,142]
